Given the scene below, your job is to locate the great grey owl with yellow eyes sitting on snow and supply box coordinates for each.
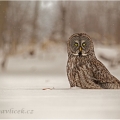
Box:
[67,33,120,89]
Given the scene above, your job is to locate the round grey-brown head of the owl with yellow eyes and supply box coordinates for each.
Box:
[68,33,94,57]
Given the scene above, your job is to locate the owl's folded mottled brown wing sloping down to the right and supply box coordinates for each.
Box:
[92,60,120,89]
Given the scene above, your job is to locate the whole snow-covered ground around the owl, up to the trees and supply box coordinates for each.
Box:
[0,44,120,119]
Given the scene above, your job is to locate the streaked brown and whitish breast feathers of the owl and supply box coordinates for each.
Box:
[67,55,101,89]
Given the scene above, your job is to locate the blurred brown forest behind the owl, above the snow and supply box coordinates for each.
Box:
[0,1,120,69]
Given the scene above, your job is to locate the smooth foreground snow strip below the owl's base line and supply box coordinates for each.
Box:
[0,89,120,119]
